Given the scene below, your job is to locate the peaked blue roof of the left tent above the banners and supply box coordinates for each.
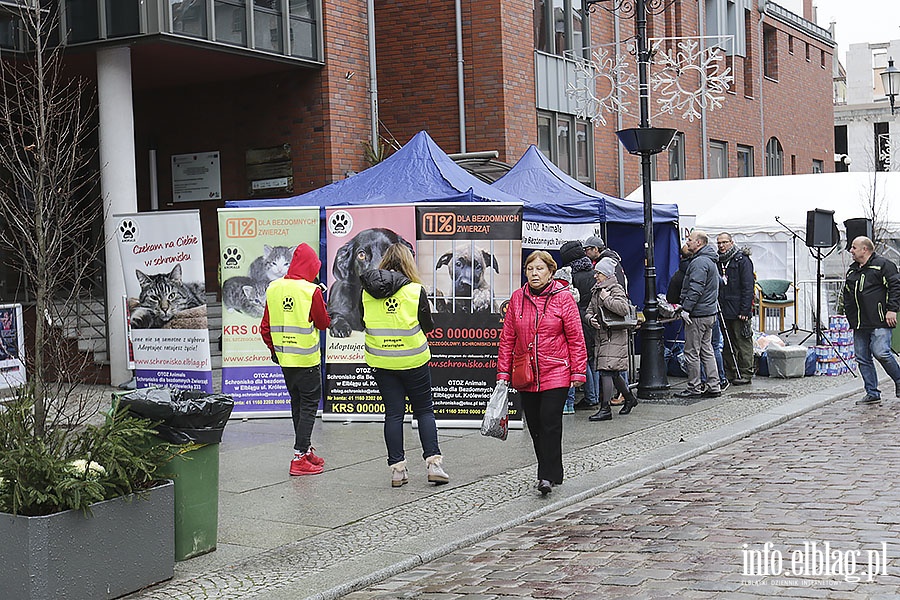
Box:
[225,131,522,208]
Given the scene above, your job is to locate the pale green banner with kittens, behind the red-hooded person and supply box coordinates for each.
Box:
[219,207,319,417]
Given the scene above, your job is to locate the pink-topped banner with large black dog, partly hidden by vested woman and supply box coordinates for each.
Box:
[322,204,416,421]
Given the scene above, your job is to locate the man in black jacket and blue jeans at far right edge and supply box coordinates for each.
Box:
[844,236,900,404]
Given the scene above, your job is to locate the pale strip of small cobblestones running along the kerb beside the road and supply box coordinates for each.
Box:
[125,378,852,600]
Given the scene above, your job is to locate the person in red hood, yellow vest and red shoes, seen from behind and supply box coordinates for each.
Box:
[259,244,331,476]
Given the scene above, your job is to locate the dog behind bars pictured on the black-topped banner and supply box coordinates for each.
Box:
[434,242,500,313]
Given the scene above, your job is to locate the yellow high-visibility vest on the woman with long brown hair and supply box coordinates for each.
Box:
[363,283,431,371]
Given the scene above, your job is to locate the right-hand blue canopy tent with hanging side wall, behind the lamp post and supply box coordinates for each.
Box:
[493,145,679,306]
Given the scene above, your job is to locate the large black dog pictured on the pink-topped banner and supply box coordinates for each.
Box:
[328,227,415,337]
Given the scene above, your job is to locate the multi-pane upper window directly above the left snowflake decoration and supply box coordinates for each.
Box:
[534,0,590,56]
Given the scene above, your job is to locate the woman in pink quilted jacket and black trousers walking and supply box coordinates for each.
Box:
[497,250,587,495]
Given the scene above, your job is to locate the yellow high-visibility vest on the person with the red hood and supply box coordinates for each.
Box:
[266,277,321,367]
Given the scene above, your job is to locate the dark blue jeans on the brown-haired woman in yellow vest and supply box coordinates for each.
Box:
[372,363,442,465]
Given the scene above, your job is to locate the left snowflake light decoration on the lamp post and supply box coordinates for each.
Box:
[566,48,637,125]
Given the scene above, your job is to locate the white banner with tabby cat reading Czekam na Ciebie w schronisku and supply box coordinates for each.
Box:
[113,210,213,392]
